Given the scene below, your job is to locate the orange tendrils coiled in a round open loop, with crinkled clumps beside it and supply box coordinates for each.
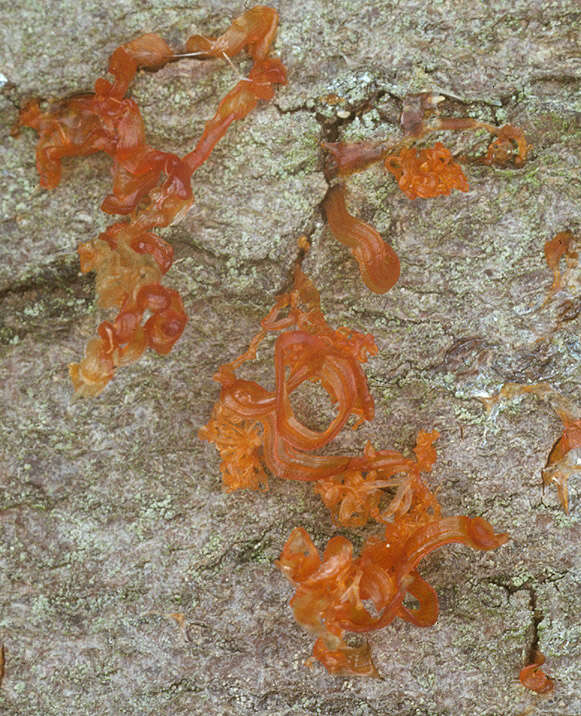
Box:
[199,268,437,496]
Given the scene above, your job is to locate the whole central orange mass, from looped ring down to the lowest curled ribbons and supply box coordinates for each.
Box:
[199,268,508,676]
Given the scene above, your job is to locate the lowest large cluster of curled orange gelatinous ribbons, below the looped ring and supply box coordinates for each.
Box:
[277,510,508,676]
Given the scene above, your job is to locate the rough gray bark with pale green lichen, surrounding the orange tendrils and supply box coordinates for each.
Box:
[0,0,581,716]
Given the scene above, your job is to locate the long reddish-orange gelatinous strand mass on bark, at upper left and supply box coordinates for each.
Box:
[20,6,286,396]
